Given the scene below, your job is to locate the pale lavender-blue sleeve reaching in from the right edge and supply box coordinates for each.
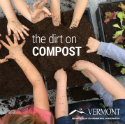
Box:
[97,42,125,65]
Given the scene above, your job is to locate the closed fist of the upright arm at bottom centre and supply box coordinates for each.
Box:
[54,69,67,83]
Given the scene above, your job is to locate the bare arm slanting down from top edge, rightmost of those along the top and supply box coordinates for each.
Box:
[70,0,88,29]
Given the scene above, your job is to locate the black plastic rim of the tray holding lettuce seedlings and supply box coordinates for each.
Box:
[96,0,125,76]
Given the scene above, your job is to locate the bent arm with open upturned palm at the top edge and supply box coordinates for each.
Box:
[13,0,51,23]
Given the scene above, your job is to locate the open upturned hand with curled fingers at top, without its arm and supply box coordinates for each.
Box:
[27,0,52,23]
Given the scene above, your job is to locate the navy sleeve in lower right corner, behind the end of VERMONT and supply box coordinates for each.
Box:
[113,99,125,124]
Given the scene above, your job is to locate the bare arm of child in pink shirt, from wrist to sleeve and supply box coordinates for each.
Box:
[15,54,49,111]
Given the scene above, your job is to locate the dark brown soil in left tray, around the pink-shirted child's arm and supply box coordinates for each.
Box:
[0,16,39,98]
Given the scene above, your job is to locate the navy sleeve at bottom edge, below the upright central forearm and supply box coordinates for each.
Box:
[55,116,74,124]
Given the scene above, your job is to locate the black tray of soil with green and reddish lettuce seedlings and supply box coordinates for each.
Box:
[96,1,125,76]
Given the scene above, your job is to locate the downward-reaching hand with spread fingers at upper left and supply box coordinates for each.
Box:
[7,19,29,40]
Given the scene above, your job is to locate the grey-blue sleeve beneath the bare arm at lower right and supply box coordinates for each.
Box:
[91,81,113,108]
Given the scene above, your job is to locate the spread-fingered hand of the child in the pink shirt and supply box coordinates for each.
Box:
[1,35,25,59]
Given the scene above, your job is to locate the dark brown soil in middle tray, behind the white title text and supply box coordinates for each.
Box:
[36,12,101,90]
